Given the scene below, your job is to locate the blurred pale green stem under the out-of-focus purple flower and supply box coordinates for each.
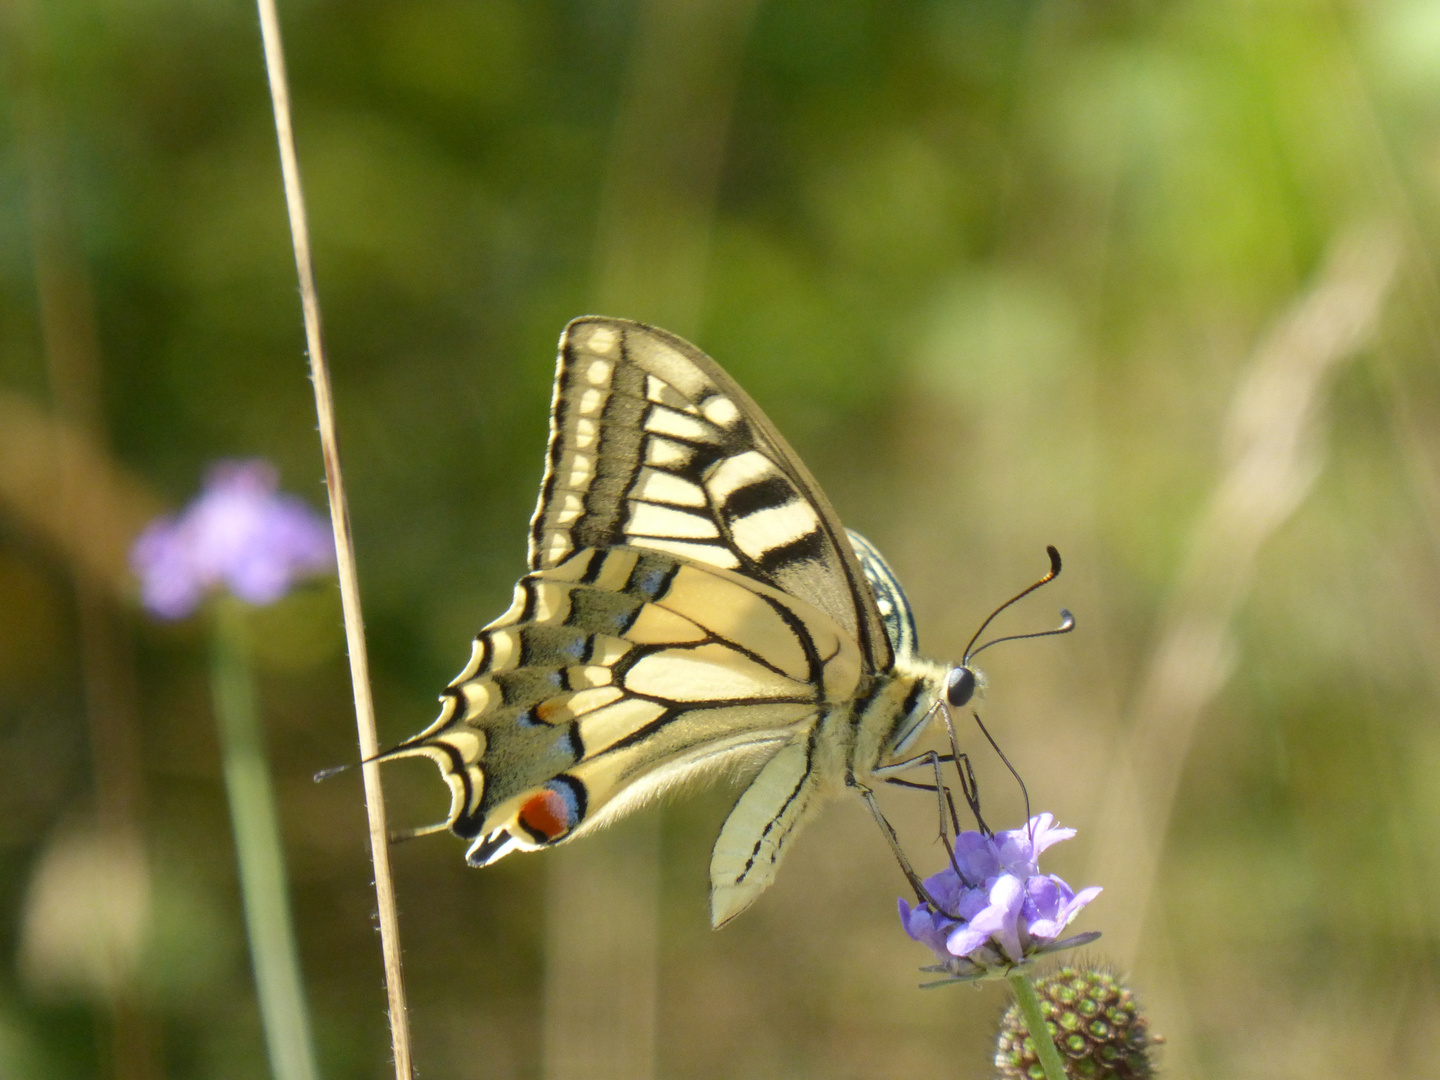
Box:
[210,596,320,1080]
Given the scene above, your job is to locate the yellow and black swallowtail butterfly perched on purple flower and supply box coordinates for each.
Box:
[383,317,1058,926]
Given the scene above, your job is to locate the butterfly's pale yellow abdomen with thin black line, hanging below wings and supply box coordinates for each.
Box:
[710,742,821,929]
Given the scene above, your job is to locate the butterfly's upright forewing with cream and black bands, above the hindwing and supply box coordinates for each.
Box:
[530,318,891,668]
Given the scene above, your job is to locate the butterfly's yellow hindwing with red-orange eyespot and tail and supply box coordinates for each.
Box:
[397,547,861,864]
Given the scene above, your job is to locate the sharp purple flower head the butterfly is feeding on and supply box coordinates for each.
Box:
[900,814,1100,979]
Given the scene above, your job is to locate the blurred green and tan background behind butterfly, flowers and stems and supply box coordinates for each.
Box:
[0,0,1440,1080]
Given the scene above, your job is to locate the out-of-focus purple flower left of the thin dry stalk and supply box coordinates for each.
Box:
[130,461,336,619]
